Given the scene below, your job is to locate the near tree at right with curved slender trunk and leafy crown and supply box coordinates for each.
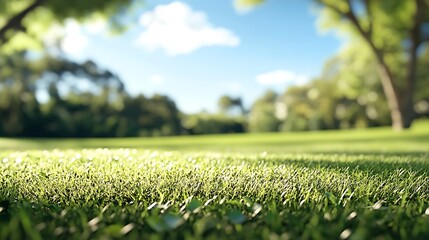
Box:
[239,0,429,130]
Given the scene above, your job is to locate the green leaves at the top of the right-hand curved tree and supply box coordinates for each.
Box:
[316,0,416,49]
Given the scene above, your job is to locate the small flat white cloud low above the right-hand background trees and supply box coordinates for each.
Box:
[256,70,308,85]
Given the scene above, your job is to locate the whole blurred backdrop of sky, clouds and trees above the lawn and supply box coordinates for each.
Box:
[0,0,429,137]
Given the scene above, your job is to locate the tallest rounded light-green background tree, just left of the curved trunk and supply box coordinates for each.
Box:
[317,42,392,127]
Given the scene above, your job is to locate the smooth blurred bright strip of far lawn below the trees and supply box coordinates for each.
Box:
[0,121,429,153]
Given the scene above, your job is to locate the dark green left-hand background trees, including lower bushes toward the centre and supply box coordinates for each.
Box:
[0,53,181,137]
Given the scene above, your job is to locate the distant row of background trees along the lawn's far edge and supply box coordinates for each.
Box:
[0,45,429,137]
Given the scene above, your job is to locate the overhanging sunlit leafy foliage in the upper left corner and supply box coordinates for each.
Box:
[0,0,136,49]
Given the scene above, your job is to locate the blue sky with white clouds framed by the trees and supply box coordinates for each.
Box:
[53,0,341,113]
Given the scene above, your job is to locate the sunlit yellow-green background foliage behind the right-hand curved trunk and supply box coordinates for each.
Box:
[280,37,429,131]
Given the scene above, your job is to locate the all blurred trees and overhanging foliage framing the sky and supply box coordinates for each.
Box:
[0,0,429,137]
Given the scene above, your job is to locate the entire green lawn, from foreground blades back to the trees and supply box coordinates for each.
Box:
[0,121,429,239]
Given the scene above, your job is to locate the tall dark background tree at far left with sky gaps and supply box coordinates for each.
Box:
[0,52,124,137]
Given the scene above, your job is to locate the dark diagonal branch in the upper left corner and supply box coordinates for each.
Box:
[0,0,44,45]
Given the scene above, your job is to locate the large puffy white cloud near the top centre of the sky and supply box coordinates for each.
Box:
[136,1,240,56]
